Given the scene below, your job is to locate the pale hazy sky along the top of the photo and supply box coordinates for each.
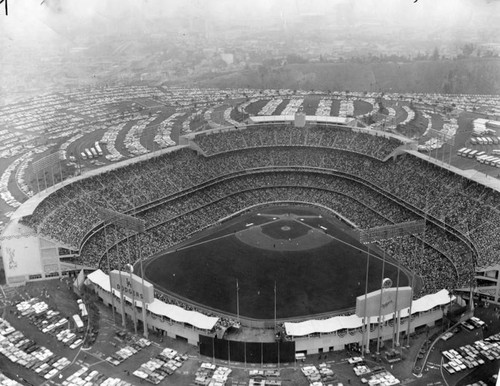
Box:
[0,0,500,43]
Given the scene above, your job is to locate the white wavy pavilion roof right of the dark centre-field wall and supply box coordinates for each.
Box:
[284,289,455,336]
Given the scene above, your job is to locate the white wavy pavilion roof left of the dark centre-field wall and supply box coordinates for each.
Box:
[87,269,219,330]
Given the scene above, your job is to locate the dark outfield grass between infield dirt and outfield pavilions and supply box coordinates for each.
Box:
[145,211,408,319]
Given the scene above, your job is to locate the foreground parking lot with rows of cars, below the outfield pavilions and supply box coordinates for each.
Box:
[0,280,500,386]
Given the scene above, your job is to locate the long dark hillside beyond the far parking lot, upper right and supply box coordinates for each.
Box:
[195,58,500,94]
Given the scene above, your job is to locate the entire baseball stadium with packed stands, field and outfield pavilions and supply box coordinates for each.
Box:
[2,113,500,362]
